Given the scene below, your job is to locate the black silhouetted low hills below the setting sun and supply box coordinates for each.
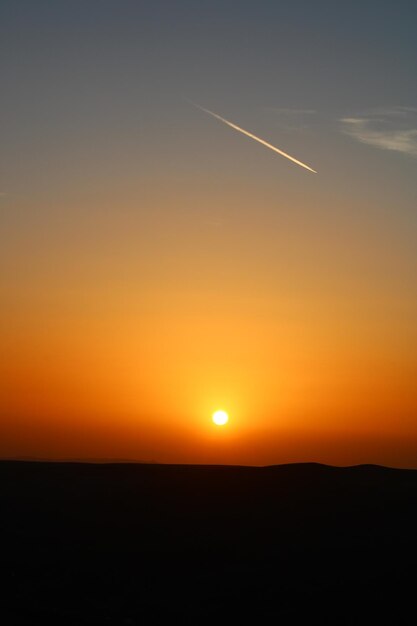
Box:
[0,461,417,626]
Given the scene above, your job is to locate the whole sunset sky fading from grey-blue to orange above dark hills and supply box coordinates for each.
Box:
[0,0,417,467]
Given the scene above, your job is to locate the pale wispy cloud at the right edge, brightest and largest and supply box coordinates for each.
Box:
[340,107,417,157]
